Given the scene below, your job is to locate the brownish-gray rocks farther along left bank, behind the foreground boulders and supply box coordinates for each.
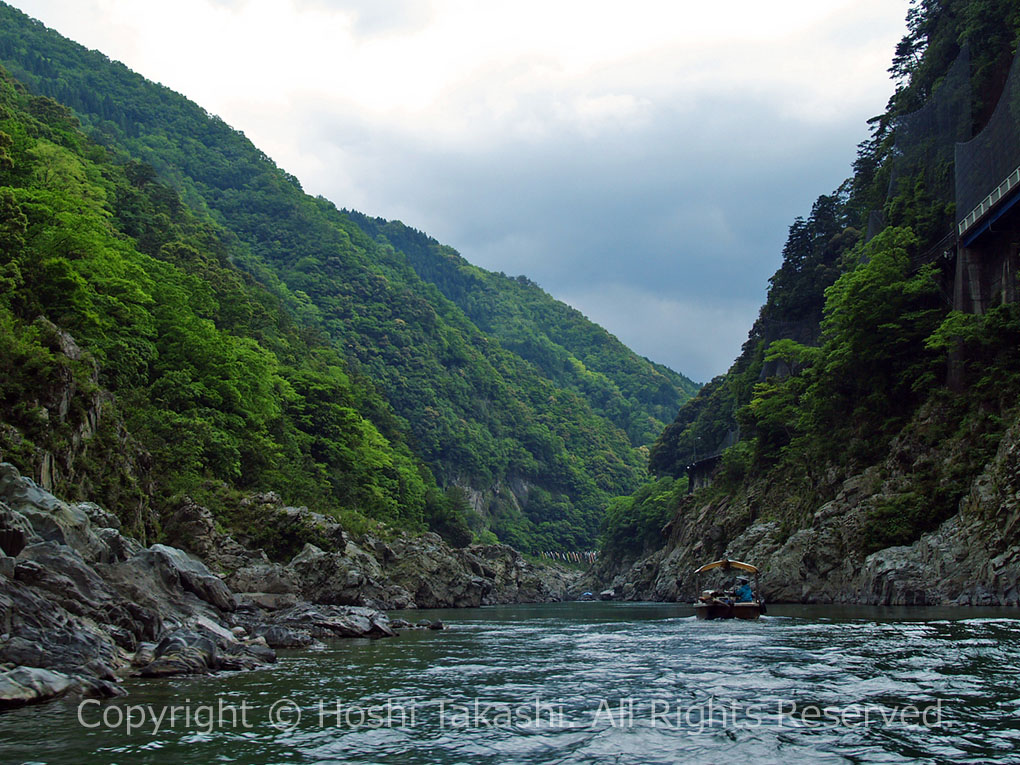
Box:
[167,494,576,610]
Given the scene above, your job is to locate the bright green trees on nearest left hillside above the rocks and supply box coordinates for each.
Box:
[0,62,435,529]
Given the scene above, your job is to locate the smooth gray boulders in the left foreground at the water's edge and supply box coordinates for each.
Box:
[0,463,393,709]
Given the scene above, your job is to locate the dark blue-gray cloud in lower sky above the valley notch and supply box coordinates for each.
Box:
[297,89,865,380]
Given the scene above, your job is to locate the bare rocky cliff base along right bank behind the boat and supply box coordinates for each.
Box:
[590,403,1020,606]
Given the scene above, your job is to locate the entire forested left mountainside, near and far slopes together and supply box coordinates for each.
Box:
[0,0,695,550]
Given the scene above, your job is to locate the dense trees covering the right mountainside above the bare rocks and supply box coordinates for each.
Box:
[604,0,1020,554]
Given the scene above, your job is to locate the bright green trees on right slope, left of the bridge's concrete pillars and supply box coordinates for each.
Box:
[741,227,945,464]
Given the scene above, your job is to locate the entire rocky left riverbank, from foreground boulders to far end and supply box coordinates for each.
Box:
[0,463,571,709]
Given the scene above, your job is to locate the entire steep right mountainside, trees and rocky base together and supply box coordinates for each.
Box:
[604,0,1020,603]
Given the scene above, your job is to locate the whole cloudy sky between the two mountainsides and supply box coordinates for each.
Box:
[15,0,908,380]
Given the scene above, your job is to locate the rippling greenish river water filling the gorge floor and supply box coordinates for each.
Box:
[0,603,1020,765]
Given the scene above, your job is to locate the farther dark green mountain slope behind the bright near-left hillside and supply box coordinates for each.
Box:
[0,5,691,550]
